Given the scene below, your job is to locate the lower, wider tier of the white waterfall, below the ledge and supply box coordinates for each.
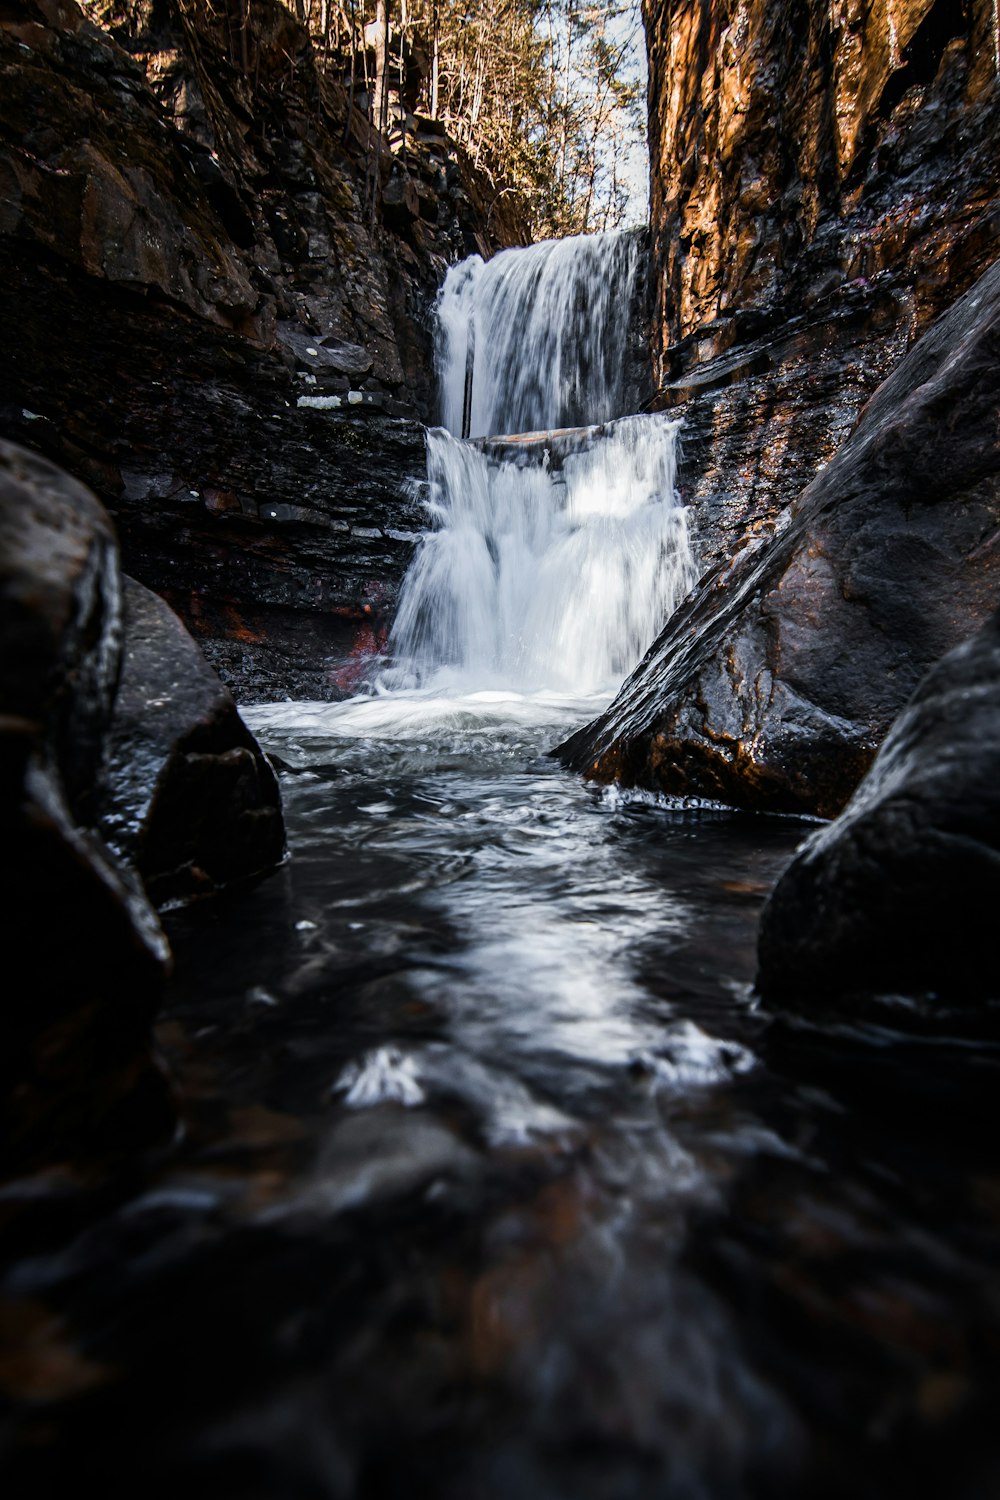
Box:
[390,417,694,695]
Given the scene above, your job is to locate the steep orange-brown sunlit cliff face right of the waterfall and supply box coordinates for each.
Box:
[645,0,1000,563]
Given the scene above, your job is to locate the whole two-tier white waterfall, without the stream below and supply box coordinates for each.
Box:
[374,234,696,714]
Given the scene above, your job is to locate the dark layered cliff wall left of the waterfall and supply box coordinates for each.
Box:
[0,0,522,698]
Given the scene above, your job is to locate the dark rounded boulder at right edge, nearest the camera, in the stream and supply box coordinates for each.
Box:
[757,615,1000,1013]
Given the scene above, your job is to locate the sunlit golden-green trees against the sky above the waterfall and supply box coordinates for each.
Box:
[305,0,645,237]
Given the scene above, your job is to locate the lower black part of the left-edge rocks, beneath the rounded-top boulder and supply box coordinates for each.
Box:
[0,750,174,1173]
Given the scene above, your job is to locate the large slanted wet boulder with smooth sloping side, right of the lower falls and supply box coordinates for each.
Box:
[559,264,1000,816]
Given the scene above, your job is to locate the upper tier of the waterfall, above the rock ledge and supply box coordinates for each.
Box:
[436,233,639,437]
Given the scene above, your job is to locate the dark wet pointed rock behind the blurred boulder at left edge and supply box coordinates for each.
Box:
[100,579,285,903]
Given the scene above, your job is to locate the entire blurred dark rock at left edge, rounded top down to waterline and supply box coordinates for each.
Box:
[0,444,172,1172]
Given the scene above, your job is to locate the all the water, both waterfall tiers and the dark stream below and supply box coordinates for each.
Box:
[7,239,1000,1500]
